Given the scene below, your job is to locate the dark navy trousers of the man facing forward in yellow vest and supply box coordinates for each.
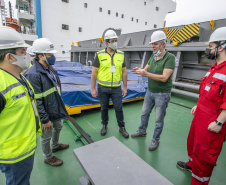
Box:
[98,84,125,127]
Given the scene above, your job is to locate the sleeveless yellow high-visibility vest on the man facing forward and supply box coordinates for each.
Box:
[97,49,124,87]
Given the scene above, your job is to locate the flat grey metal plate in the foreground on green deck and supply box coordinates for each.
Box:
[74,137,172,185]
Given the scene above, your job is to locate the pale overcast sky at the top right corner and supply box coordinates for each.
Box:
[166,0,226,27]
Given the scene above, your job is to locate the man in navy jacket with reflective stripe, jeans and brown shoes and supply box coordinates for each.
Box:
[24,38,69,166]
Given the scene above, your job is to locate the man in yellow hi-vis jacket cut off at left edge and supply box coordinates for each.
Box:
[0,27,41,185]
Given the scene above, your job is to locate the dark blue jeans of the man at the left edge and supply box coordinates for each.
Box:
[0,154,34,185]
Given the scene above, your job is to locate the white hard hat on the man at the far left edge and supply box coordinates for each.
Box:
[0,26,30,50]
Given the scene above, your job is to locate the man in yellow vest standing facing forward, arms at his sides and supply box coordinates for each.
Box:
[91,30,129,138]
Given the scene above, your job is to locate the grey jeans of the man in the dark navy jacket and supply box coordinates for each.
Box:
[41,120,63,159]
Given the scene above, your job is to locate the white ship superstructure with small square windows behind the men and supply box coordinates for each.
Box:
[35,0,176,60]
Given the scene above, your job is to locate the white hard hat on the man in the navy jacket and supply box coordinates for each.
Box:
[32,38,57,54]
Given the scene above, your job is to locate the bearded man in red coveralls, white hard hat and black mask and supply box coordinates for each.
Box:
[177,27,226,184]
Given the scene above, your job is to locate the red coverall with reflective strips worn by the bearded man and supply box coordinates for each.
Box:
[187,61,226,185]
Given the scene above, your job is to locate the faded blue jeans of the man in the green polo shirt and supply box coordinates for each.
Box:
[139,89,171,141]
